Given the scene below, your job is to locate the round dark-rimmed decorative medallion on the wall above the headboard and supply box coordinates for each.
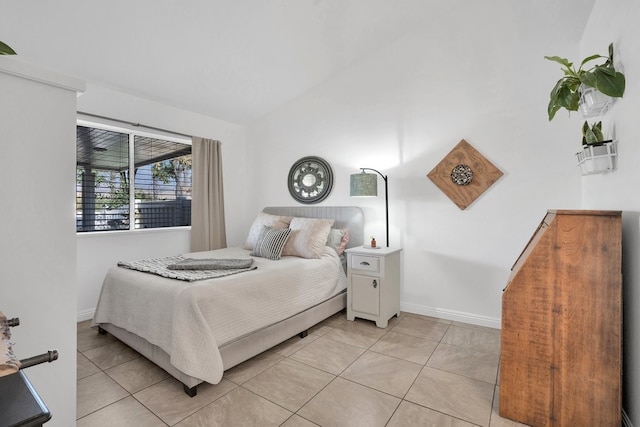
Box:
[287,156,333,204]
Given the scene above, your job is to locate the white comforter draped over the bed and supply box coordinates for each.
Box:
[93,247,346,384]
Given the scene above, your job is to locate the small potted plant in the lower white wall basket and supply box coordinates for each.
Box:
[576,121,618,175]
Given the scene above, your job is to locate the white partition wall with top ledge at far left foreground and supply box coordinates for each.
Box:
[0,57,84,426]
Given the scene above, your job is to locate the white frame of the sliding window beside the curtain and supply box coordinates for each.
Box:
[74,118,193,236]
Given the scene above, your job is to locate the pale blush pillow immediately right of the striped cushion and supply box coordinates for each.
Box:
[282,218,334,258]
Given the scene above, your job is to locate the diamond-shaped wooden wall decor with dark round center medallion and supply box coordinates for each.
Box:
[427,139,502,209]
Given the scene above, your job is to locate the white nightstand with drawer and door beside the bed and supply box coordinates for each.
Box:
[345,246,402,328]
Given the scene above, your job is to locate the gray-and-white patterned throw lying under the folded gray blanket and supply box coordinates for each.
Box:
[118,255,257,282]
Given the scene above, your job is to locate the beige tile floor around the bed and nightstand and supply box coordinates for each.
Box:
[77,312,521,427]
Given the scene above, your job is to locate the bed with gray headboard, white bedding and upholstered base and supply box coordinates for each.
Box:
[93,206,364,396]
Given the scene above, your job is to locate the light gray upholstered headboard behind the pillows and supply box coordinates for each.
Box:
[263,206,364,248]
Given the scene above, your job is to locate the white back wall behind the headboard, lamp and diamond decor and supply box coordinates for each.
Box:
[247,0,580,327]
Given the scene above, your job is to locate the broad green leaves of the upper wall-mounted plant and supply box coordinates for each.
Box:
[545,43,625,120]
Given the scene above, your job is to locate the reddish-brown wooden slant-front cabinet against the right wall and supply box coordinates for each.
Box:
[500,210,622,427]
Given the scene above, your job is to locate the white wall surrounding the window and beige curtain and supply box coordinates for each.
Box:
[74,84,248,321]
